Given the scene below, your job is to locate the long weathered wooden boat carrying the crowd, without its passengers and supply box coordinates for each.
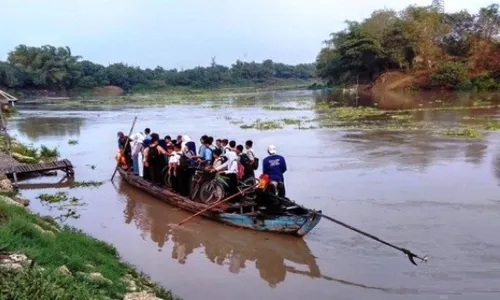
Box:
[118,168,321,236]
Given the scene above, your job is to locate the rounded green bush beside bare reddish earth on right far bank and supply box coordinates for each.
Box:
[430,62,468,88]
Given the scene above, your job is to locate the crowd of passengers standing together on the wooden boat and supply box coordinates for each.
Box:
[118,128,287,197]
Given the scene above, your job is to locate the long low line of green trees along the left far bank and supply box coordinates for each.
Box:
[0,45,315,90]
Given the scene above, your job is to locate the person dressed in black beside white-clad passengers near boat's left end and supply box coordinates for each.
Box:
[144,133,167,185]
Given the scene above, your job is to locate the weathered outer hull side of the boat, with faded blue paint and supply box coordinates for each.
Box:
[118,168,321,236]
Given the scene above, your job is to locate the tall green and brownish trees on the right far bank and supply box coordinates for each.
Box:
[316,0,500,90]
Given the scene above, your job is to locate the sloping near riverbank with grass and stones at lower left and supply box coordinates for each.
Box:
[0,178,178,300]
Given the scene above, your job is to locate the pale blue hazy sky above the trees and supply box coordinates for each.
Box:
[0,0,494,68]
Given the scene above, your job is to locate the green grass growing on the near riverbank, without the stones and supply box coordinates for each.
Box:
[0,203,178,300]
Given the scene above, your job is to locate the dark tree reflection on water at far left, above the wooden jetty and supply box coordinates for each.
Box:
[13,115,85,142]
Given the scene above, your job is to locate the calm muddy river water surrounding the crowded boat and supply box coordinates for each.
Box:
[3,92,500,300]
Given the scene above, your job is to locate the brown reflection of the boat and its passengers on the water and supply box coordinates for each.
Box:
[118,181,389,291]
